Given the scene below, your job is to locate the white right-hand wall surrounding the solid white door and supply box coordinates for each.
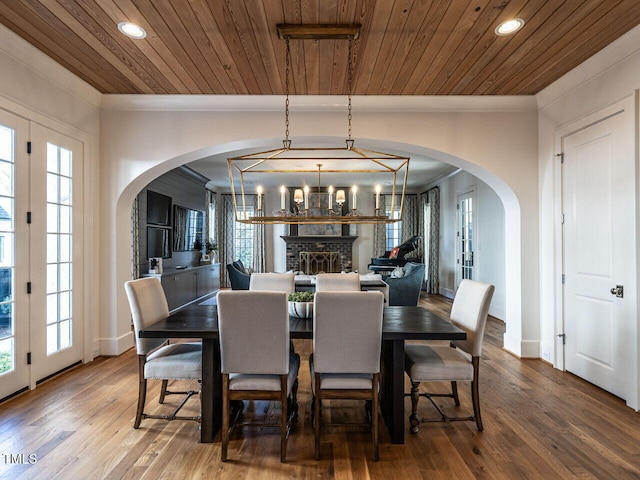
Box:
[536,27,640,409]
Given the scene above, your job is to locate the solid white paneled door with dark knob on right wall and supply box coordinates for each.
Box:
[562,109,636,399]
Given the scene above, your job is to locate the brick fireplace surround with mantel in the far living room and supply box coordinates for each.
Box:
[280,235,358,272]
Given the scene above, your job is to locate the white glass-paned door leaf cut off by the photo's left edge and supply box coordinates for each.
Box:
[0,111,29,399]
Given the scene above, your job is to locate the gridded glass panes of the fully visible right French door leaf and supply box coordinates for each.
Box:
[47,143,73,354]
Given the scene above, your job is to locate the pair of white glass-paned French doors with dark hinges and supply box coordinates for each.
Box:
[0,117,83,398]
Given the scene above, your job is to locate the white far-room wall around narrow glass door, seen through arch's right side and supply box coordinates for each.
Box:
[438,171,506,320]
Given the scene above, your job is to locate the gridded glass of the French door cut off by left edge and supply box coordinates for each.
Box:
[0,125,15,374]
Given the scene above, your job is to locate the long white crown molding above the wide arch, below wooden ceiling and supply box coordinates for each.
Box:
[101,95,537,112]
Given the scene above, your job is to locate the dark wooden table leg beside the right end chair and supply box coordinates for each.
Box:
[380,340,405,444]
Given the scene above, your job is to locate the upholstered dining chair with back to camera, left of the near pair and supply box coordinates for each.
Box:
[217,290,300,462]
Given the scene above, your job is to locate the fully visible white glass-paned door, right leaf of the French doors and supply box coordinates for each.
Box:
[31,125,84,381]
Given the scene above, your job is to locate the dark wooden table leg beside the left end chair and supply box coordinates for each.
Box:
[200,338,222,443]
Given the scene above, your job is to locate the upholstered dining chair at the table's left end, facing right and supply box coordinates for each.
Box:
[124,277,202,428]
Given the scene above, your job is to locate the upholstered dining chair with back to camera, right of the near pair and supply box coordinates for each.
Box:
[309,292,384,461]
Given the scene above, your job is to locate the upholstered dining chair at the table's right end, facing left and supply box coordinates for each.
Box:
[405,280,495,433]
